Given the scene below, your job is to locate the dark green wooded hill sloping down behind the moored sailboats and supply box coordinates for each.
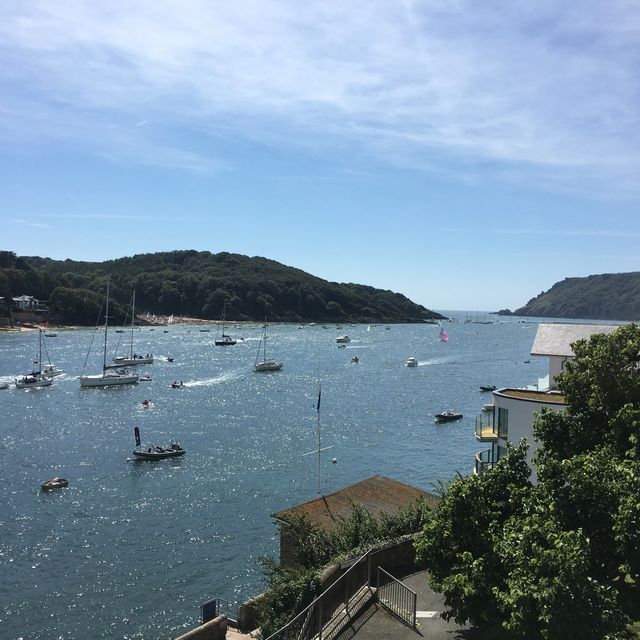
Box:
[0,251,442,324]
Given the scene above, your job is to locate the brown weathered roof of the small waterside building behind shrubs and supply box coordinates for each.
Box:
[272,476,440,529]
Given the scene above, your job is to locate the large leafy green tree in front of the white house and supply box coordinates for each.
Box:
[417,325,640,640]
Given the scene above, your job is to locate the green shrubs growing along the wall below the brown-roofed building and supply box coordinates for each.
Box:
[259,498,430,638]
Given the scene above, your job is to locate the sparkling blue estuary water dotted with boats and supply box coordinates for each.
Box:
[0,312,547,640]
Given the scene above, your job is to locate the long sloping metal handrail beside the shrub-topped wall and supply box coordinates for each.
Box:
[266,550,371,640]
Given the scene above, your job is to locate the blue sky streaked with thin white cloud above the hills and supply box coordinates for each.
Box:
[0,0,640,310]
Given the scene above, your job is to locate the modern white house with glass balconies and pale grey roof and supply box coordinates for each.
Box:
[474,323,619,483]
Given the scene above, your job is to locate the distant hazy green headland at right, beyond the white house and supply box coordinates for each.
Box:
[513,272,640,321]
